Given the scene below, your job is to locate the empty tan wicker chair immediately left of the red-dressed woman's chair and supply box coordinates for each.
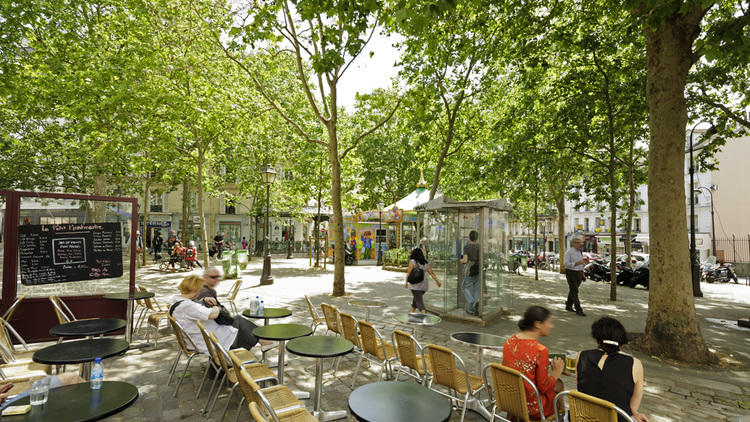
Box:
[427,344,484,422]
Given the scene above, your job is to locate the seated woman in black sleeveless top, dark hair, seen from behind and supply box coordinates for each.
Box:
[576,317,648,422]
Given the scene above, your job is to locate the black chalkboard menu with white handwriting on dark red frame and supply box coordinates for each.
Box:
[18,223,122,286]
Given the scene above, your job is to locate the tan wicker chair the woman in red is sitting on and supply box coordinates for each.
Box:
[482,363,554,422]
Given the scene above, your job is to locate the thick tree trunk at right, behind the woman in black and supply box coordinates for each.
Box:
[644,6,715,363]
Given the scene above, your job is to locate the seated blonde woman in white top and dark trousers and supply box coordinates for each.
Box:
[169,275,268,353]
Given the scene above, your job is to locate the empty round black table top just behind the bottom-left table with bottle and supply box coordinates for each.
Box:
[32,338,129,365]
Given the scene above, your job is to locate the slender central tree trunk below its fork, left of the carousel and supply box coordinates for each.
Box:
[326,121,346,296]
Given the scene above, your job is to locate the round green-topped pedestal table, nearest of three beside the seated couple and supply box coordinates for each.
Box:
[286,334,354,422]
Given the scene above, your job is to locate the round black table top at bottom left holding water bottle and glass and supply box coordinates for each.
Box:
[2,381,138,422]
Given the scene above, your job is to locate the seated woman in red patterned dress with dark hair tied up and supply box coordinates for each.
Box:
[503,306,565,419]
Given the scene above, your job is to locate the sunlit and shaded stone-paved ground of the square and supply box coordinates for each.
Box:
[73,258,750,422]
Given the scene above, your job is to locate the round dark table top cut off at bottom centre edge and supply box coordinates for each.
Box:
[349,381,451,422]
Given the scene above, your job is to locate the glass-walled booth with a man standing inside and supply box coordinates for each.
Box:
[416,196,513,325]
